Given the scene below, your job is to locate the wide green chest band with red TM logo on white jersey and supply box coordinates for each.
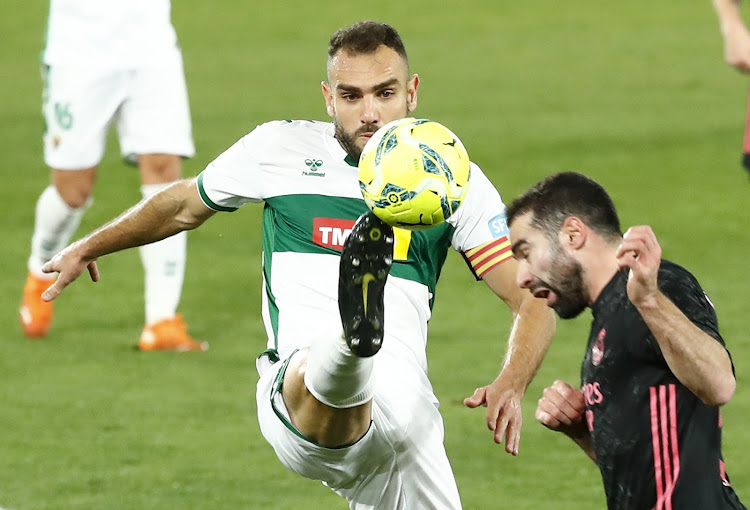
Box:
[263,195,454,297]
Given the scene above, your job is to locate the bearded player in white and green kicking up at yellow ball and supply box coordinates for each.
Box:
[43,21,555,510]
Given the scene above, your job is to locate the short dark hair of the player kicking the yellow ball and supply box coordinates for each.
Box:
[328,20,409,67]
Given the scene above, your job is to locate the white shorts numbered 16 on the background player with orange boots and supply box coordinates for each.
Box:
[42,52,195,170]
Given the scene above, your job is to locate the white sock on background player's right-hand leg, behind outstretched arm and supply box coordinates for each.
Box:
[139,183,187,324]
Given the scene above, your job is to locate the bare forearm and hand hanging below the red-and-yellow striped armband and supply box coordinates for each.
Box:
[464,259,556,455]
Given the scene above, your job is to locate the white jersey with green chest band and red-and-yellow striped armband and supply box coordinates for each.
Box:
[197,121,510,371]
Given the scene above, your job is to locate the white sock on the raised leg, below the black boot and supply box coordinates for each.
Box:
[305,336,374,408]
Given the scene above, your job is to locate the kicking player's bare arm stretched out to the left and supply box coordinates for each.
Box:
[42,179,214,301]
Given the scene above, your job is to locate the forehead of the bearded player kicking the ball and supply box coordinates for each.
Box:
[328,46,408,85]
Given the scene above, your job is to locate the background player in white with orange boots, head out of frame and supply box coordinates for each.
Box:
[19,0,208,351]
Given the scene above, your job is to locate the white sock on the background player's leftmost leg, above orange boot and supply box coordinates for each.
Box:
[28,185,91,278]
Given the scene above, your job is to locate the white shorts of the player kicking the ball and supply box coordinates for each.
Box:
[256,351,461,510]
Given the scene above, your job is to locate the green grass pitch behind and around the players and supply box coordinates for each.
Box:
[0,0,750,510]
